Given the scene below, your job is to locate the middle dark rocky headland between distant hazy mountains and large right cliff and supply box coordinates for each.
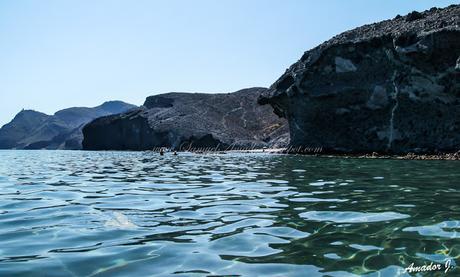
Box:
[83,88,288,150]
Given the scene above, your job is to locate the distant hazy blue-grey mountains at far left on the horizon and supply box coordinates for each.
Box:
[0,101,136,149]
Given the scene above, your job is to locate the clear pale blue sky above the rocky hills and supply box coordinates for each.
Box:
[0,0,458,125]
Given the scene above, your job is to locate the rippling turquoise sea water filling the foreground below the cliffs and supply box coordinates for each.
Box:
[0,151,460,276]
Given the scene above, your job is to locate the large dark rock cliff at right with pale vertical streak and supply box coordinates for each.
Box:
[259,5,460,153]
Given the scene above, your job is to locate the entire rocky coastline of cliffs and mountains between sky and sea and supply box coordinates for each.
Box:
[0,5,460,155]
